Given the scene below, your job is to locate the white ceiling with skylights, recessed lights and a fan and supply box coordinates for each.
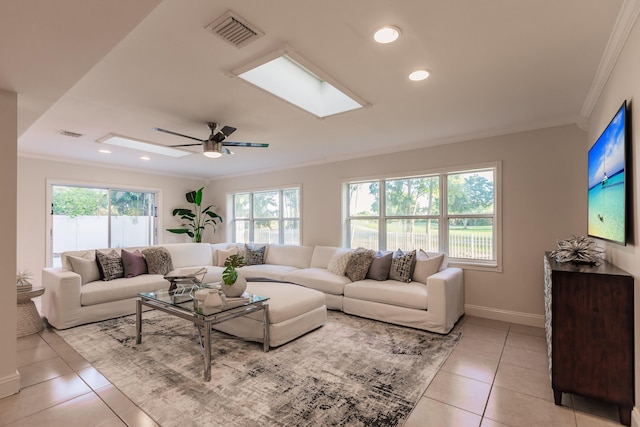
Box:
[0,0,635,179]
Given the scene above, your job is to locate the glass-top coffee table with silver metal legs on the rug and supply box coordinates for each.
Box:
[136,285,269,381]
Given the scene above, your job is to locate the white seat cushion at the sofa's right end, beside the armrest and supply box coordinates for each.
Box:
[344,279,428,310]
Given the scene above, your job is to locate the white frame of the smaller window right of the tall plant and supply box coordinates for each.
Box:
[227,185,302,245]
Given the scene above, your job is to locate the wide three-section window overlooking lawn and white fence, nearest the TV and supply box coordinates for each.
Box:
[344,163,500,267]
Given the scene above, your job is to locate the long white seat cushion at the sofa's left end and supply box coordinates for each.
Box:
[80,274,169,306]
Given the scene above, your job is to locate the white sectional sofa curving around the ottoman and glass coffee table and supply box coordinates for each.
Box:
[42,243,464,334]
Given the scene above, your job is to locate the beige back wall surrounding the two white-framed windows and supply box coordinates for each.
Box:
[209,125,587,326]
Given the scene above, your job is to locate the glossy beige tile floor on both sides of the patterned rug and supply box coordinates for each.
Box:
[0,310,620,427]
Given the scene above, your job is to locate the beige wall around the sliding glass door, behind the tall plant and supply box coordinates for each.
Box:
[16,157,208,285]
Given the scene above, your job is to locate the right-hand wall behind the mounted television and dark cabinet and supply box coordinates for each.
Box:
[583,14,640,427]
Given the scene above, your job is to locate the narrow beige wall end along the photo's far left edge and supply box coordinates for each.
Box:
[0,90,20,398]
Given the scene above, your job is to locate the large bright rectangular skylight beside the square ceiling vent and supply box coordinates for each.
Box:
[231,48,369,117]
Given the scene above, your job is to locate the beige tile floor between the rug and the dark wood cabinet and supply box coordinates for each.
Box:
[404,316,621,427]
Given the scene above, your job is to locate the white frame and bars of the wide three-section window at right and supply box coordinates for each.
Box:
[342,161,502,272]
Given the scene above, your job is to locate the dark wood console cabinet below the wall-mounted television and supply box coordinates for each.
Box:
[544,253,635,425]
